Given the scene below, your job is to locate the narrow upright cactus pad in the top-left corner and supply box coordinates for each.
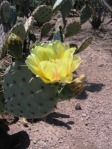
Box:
[0,0,10,24]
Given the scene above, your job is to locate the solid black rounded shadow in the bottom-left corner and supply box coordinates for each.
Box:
[0,120,30,149]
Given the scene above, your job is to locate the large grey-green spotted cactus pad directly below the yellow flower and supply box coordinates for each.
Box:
[3,61,58,118]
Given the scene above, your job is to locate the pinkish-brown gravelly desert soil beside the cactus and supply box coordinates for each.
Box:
[0,16,112,149]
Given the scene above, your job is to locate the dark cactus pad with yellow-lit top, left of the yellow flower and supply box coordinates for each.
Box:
[8,33,23,60]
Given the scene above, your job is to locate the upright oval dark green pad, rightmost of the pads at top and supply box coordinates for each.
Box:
[80,4,92,24]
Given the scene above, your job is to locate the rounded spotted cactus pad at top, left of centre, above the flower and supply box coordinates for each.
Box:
[32,5,52,23]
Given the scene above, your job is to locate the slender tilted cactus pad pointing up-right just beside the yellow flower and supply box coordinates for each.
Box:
[75,37,93,54]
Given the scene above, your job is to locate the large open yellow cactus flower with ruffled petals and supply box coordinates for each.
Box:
[26,41,81,83]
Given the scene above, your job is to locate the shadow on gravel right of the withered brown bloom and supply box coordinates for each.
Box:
[76,83,105,100]
